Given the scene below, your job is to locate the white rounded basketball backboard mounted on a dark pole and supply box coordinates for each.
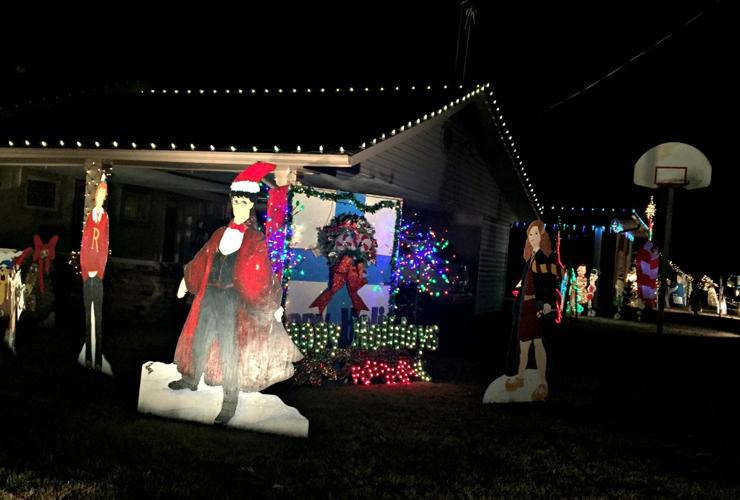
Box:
[634,142,712,189]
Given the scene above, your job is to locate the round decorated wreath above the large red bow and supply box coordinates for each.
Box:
[318,214,378,266]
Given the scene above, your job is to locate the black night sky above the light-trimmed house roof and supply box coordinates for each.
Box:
[0,0,740,274]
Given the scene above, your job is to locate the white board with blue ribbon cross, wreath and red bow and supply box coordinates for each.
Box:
[285,186,401,342]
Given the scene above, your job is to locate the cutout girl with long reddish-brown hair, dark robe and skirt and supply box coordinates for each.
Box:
[505,220,562,401]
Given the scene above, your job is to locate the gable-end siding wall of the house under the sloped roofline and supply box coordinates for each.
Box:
[361,101,522,313]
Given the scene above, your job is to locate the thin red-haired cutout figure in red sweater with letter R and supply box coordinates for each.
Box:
[80,179,108,371]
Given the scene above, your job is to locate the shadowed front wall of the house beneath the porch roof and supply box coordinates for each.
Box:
[0,166,226,322]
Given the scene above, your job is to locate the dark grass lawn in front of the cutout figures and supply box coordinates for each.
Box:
[0,310,740,499]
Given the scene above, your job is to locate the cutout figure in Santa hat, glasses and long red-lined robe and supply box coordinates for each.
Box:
[169,162,302,425]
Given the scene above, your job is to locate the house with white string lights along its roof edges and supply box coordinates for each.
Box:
[0,80,541,317]
